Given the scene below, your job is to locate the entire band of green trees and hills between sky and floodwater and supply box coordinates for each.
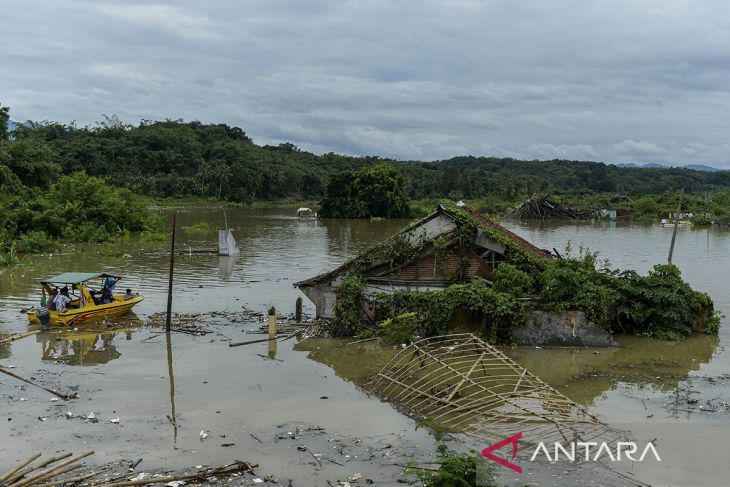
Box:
[0,105,730,237]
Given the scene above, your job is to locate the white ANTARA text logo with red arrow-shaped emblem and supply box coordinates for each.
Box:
[482,432,662,473]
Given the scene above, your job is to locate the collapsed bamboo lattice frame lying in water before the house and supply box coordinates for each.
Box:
[372,333,621,444]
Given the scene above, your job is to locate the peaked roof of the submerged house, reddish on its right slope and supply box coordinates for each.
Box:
[294,203,553,287]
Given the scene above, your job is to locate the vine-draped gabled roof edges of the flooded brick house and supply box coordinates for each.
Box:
[294,201,553,287]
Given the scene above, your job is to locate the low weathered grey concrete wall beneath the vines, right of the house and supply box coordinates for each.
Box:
[512,310,619,347]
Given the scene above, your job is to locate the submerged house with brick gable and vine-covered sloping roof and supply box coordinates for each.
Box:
[294,203,553,318]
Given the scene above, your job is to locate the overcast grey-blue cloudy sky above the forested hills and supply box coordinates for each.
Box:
[0,0,730,168]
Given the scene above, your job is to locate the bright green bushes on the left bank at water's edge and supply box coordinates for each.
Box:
[0,104,163,254]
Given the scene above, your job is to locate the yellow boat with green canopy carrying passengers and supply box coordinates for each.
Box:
[28,272,144,326]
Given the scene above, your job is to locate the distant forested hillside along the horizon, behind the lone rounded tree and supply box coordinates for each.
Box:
[5,118,730,202]
